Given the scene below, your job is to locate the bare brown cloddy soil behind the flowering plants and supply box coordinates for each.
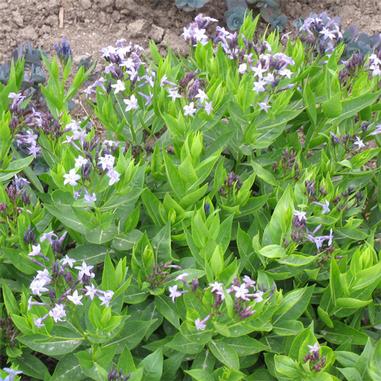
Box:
[0,0,381,62]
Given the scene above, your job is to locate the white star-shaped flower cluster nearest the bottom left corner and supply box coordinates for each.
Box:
[28,232,114,328]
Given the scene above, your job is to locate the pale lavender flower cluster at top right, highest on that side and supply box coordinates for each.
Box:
[299,13,343,53]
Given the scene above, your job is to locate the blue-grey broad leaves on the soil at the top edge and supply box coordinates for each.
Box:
[176,0,287,30]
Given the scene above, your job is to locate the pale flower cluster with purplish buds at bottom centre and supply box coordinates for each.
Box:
[168,273,264,330]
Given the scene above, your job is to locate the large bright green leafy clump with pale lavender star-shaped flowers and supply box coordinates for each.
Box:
[0,11,381,381]
